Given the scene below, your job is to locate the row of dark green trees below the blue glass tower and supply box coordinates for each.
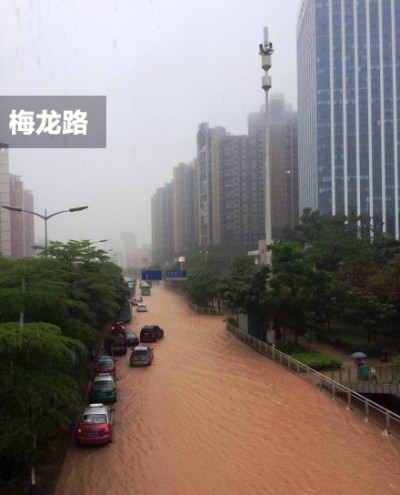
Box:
[182,210,400,348]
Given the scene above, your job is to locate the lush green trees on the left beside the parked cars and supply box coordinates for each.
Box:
[0,240,129,493]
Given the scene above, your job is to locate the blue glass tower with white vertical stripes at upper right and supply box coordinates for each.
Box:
[297,0,400,238]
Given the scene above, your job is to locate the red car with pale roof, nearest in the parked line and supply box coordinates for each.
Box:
[75,403,114,445]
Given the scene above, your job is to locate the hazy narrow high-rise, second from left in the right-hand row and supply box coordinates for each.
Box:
[173,160,197,256]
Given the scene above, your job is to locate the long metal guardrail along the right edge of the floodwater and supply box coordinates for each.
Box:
[226,323,400,439]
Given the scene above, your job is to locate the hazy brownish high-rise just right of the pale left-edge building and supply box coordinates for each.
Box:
[10,174,35,259]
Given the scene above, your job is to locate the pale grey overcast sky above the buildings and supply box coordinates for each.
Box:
[0,0,300,245]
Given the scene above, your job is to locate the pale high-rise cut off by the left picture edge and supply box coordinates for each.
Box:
[0,143,11,258]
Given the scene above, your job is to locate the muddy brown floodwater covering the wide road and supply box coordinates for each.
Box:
[55,286,400,495]
